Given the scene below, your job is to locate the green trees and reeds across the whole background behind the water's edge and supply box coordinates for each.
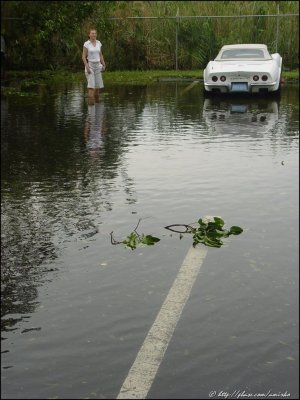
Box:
[1,1,299,71]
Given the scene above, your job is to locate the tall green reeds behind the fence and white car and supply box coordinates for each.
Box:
[102,1,299,69]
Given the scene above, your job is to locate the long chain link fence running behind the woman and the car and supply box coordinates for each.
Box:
[1,6,299,71]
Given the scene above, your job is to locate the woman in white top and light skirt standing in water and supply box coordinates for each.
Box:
[82,29,105,104]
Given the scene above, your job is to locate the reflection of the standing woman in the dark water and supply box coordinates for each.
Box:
[84,103,105,154]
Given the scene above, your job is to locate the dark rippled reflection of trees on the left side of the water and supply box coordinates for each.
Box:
[1,88,139,340]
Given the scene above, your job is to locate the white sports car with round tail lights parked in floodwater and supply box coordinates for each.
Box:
[203,44,282,93]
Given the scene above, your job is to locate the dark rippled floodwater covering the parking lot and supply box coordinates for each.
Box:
[1,82,299,399]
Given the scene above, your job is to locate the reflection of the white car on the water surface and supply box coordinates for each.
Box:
[203,98,279,137]
